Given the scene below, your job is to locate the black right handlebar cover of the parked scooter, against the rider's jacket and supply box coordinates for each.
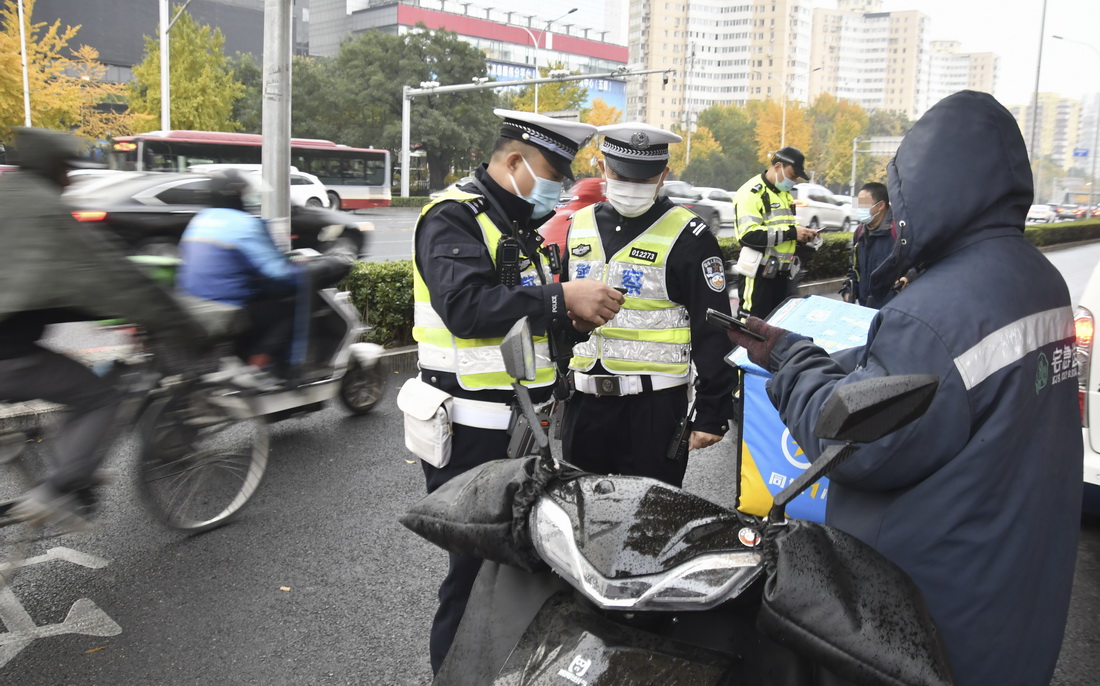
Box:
[757,519,954,686]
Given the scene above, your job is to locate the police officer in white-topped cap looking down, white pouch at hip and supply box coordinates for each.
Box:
[414,110,623,672]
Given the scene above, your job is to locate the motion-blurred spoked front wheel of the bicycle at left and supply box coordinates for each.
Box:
[139,383,271,531]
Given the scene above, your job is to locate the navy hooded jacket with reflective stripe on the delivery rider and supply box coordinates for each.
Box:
[769,91,1082,686]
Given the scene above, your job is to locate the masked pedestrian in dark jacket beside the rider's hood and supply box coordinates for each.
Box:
[840,181,898,309]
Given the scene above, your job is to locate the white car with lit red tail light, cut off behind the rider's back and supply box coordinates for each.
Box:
[1074,265,1100,515]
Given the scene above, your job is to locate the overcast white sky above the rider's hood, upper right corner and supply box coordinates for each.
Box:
[875,0,1100,106]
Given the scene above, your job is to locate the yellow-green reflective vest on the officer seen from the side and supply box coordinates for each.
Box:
[413,189,554,390]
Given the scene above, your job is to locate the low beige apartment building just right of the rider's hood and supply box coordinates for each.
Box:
[1009,92,1095,169]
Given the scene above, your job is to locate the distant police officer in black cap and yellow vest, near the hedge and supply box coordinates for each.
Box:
[734,146,817,319]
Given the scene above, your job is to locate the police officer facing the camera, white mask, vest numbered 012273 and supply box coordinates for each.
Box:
[562,122,735,486]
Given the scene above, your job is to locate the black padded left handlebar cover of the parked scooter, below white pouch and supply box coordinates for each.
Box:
[399,457,582,572]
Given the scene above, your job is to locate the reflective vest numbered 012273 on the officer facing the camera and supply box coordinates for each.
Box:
[568,206,697,377]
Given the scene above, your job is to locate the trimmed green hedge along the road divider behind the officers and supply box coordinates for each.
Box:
[341,219,1100,347]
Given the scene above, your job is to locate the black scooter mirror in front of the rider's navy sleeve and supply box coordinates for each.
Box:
[814,374,939,443]
